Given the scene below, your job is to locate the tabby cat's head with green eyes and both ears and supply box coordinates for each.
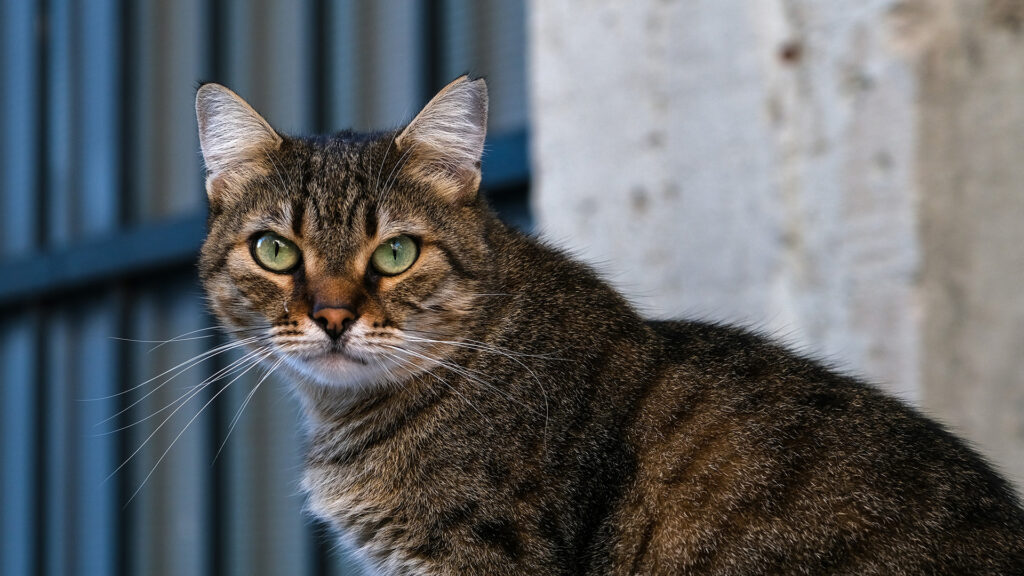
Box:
[196,77,493,386]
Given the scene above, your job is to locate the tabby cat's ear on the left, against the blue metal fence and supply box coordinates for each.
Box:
[196,83,284,201]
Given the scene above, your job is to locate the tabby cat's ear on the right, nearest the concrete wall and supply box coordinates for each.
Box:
[394,76,487,202]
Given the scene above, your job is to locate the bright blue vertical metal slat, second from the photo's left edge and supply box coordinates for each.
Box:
[75,0,124,574]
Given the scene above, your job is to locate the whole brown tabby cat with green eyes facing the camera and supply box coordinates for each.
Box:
[196,77,1024,575]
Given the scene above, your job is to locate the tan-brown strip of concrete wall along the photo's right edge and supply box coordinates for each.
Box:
[918,0,1024,485]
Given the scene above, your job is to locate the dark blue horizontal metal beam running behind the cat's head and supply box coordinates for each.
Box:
[0,130,529,308]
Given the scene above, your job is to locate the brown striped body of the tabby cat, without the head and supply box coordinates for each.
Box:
[305,217,1024,574]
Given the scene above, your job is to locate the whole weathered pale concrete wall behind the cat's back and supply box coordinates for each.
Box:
[529,0,1024,480]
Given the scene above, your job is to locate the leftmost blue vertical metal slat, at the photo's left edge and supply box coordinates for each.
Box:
[0,1,43,575]
